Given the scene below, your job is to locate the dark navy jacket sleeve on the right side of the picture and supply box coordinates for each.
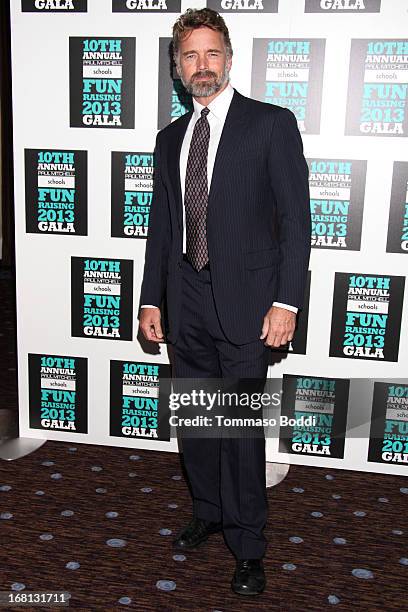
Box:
[269,108,311,308]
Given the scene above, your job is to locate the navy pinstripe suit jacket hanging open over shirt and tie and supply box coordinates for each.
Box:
[139,90,311,344]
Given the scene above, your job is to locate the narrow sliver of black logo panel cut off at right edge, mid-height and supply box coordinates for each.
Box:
[387,162,408,253]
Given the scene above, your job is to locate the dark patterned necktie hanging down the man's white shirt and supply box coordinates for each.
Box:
[184,108,210,272]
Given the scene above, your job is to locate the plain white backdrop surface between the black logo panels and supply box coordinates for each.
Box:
[12,0,408,474]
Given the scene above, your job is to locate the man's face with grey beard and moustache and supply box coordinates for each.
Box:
[177,26,232,98]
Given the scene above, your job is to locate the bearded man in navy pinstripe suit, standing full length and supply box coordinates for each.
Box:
[139,8,311,595]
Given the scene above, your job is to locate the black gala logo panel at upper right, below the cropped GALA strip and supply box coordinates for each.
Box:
[345,39,408,136]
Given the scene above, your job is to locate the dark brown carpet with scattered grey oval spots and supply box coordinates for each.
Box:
[0,274,408,612]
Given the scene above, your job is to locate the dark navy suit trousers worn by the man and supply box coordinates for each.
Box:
[172,257,269,559]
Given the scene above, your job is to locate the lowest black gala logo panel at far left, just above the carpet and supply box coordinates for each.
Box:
[28,353,88,433]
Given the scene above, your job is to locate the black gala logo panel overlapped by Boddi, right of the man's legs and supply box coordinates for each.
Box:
[279,374,349,459]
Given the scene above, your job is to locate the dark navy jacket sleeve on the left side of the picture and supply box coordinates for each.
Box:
[139,132,171,309]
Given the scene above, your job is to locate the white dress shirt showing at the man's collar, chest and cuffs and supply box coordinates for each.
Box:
[141,83,298,312]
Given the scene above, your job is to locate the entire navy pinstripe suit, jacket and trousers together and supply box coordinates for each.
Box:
[139,91,311,559]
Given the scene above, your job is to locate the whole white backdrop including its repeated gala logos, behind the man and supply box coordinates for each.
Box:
[11,0,408,474]
